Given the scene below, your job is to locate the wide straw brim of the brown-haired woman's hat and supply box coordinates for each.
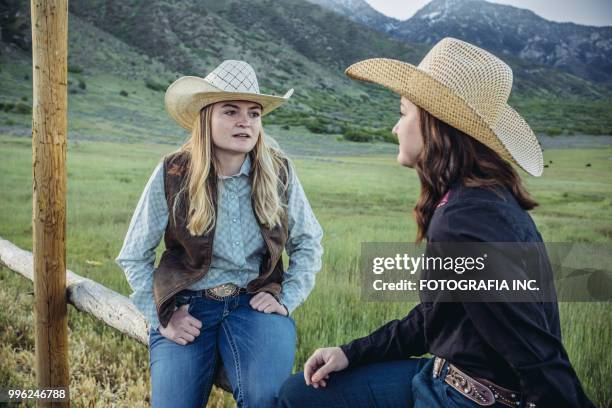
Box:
[345,58,544,176]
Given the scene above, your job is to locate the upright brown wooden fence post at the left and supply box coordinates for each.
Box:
[31,0,70,407]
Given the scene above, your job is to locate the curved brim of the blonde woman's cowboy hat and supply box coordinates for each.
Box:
[164,76,293,130]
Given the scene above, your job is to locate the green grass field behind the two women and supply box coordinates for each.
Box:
[0,136,612,407]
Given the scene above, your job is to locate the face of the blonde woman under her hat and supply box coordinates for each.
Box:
[211,101,261,154]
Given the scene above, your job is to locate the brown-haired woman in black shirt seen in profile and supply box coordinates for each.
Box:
[279,38,592,408]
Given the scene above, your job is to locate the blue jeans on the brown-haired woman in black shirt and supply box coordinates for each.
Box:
[278,358,503,408]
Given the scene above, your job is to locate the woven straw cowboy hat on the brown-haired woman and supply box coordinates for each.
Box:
[346,38,543,176]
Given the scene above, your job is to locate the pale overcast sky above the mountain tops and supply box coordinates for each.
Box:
[366,0,612,26]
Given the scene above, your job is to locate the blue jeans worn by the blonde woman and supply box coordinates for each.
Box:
[149,292,296,408]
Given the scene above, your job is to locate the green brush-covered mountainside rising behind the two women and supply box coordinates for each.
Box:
[0,0,612,140]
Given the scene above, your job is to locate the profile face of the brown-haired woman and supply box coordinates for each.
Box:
[392,96,423,167]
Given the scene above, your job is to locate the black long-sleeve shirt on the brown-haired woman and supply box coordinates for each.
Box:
[341,186,593,408]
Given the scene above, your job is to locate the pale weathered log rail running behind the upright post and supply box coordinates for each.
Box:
[0,237,149,345]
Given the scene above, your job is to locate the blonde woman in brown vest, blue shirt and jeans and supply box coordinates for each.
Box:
[116,60,322,408]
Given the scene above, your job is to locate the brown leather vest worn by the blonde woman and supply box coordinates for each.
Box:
[153,153,288,327]
